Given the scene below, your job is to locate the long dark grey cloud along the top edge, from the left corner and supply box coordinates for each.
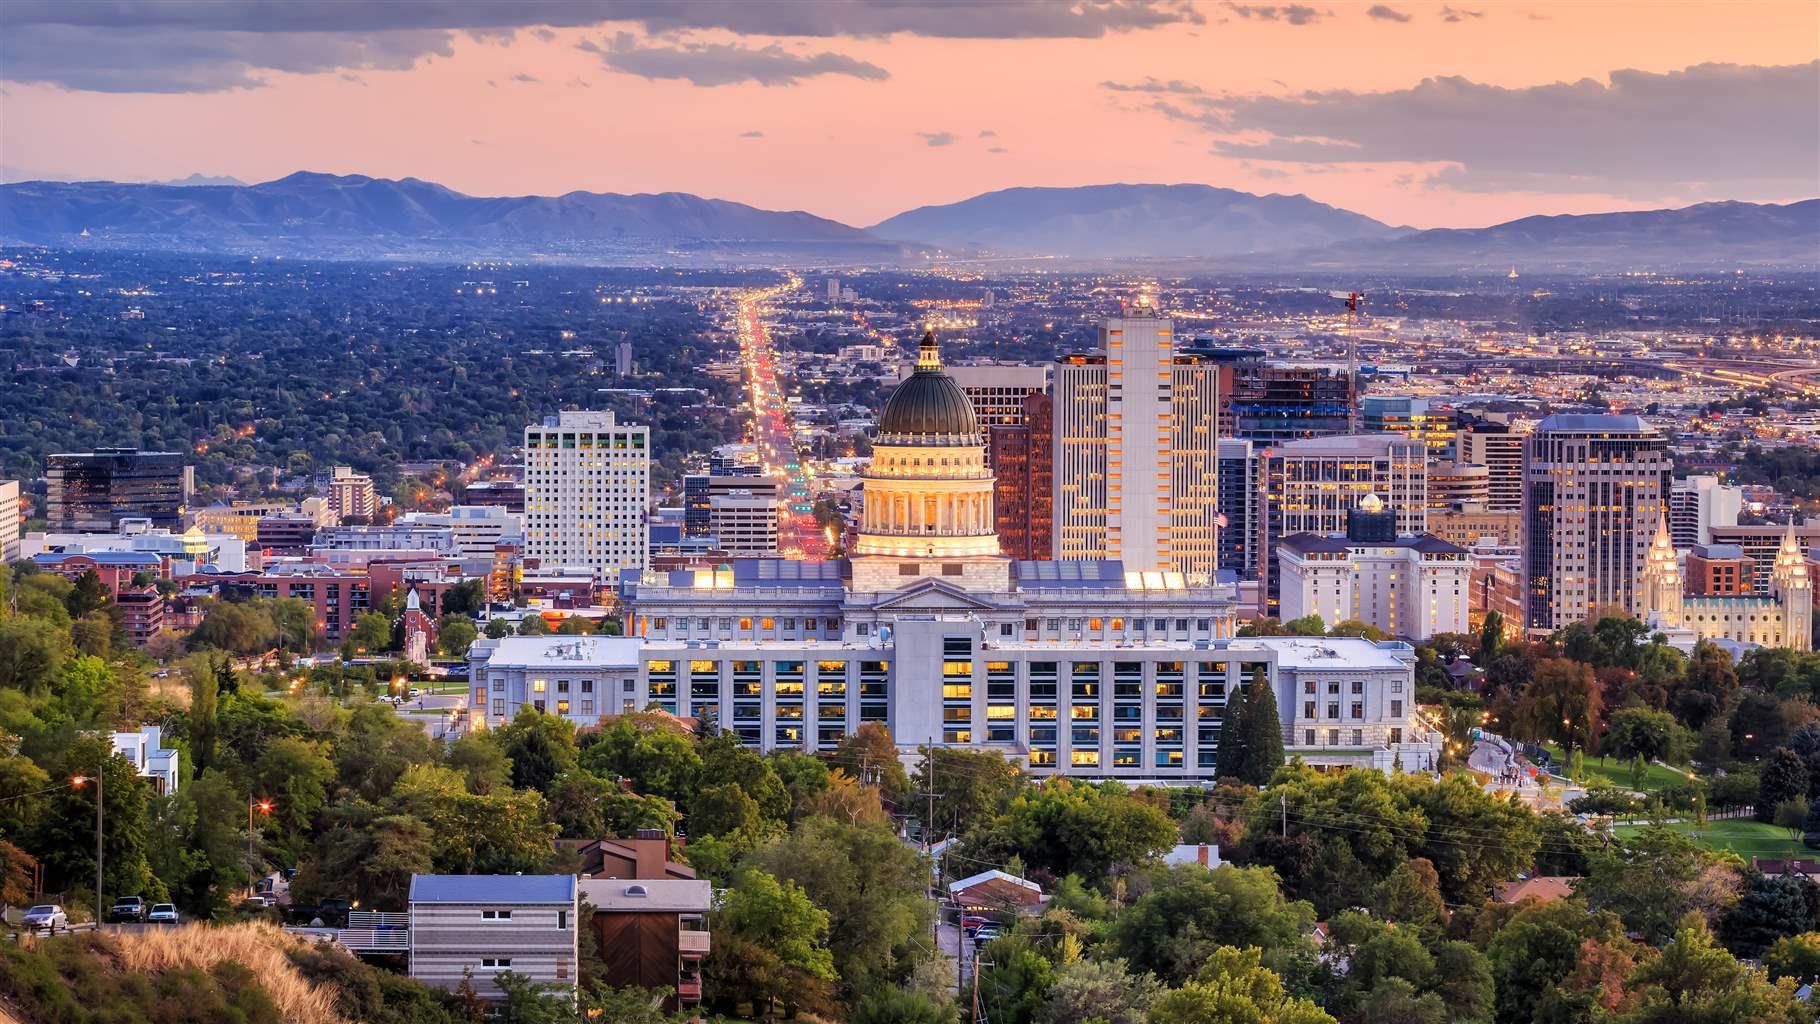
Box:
[0,0,1205,93]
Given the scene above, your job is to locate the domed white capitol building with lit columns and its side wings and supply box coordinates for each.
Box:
[470,335,1441,784]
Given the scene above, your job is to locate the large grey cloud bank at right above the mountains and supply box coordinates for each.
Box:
[1152,60,1820,198]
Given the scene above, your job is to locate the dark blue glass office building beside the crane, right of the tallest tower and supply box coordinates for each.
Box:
[1219,353,1354,444]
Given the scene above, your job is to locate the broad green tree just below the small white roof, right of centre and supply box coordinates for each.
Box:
[1112,864,1314,984]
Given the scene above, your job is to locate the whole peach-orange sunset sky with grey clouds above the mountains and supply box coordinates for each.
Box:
[0,0,1820,227]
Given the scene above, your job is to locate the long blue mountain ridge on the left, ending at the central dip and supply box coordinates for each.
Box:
[0,171,885,256]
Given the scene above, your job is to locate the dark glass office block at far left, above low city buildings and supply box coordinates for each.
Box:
[44,447,195,533]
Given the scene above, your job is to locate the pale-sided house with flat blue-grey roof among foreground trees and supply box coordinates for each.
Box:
[410,875,579,999]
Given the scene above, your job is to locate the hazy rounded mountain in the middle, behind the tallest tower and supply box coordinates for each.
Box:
[870,186,1401,260]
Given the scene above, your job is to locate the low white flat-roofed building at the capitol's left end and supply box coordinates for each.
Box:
[468,637,646,728]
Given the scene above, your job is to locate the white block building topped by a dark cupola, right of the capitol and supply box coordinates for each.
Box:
[1276,497,1472,642]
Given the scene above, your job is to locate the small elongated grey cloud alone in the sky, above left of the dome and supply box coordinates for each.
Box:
[579,33,892,85]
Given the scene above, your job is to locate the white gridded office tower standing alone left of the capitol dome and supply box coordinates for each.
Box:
[524,411,652,586]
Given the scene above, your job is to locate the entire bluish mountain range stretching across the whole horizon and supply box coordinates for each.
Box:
[0,171,1820,271]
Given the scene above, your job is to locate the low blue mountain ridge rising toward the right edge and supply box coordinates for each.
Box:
[1324,200,1820,269]
